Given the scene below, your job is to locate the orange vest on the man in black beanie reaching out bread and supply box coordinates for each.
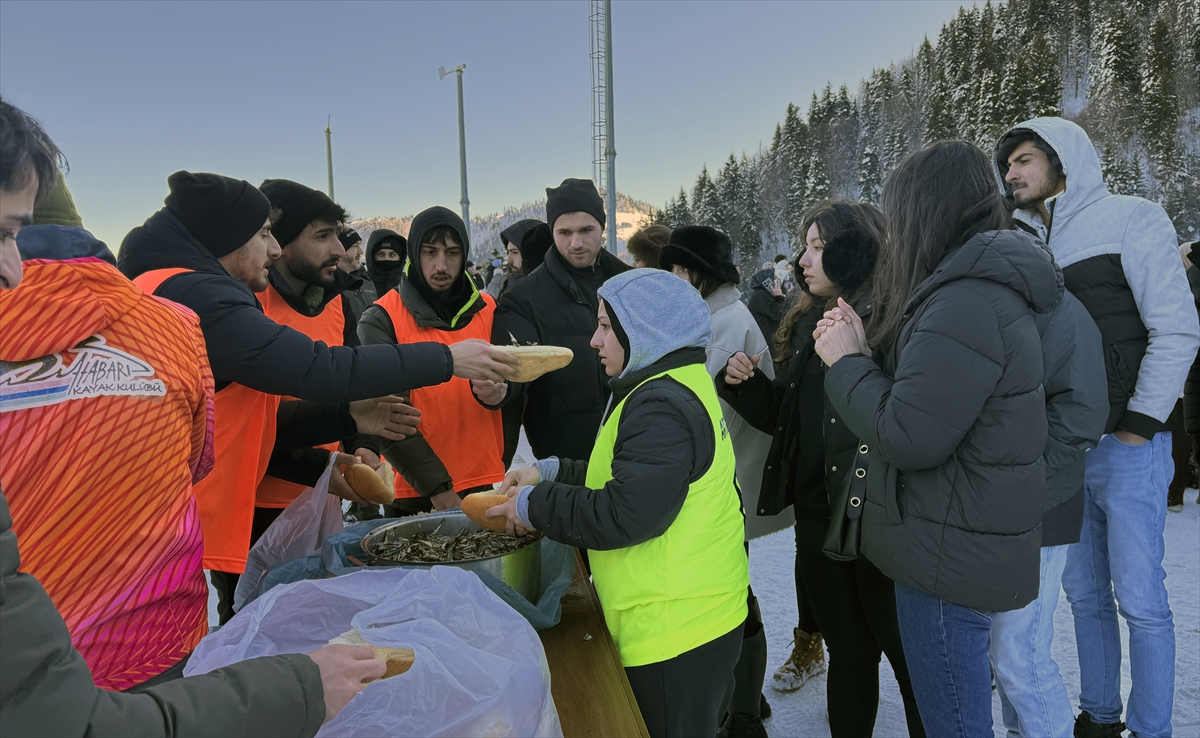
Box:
[133,269,281,574]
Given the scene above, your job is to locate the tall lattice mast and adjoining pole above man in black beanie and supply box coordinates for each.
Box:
[588,0,617,254]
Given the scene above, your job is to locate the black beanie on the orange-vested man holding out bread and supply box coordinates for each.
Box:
[163,170,271,258]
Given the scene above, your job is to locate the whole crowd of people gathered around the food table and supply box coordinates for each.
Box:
[0,92,1200,738]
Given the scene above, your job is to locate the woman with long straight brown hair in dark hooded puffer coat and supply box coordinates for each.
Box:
[815,142,1063,738]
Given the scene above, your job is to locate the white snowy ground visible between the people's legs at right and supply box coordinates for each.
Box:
[750,490,1200,738]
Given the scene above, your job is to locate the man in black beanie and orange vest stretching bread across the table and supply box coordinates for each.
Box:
[118,172,515,622]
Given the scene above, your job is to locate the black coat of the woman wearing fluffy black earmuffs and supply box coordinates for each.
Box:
[715,299,871,518]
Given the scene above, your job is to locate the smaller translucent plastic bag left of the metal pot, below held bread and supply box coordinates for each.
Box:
[233,454,343,612]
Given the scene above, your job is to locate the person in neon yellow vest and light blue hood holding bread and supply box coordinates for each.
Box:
[487,269,750,738]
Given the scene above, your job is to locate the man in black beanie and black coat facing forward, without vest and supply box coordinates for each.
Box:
[492,179,629,458]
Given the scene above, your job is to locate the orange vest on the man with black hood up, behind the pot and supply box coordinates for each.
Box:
[376,289,504,497]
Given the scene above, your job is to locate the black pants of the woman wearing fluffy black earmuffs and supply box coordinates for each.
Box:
[796,515,925,738]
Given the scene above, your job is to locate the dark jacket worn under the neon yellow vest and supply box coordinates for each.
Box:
[529,348,715,551]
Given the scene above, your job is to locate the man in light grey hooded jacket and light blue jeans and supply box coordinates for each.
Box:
[994,118,1200,738]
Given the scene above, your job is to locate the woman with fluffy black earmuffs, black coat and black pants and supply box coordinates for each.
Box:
[716,200,925,738]
